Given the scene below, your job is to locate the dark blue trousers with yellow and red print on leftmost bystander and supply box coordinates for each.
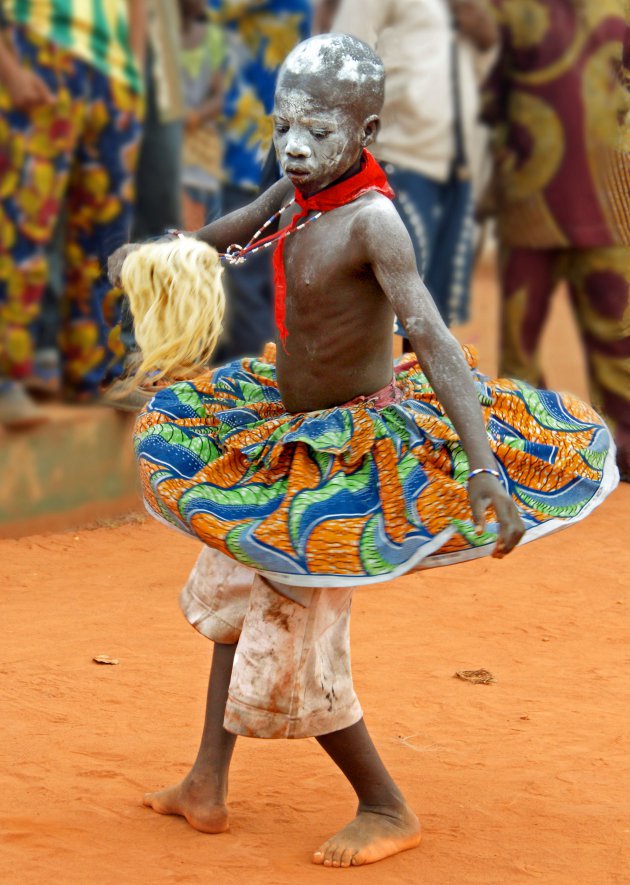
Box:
[0,26,142,386]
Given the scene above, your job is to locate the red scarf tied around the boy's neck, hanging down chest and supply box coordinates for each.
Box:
[273,150,394,351]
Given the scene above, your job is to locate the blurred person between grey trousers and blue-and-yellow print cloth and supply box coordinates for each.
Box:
[179,0,225,230]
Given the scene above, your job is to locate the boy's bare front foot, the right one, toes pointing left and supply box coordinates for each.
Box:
[313,806,420,867]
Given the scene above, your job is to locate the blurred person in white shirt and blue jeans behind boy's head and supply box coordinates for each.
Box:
[334,0,497,325]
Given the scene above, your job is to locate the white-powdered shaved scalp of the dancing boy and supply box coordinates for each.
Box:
[278,34,385,116]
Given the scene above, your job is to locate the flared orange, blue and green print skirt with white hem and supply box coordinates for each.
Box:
[135,346,618,587]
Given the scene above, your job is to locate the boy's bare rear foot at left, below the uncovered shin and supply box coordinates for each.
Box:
[142,773,229,833]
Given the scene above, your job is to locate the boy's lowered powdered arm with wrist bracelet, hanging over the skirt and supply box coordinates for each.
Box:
[358,201,525,556]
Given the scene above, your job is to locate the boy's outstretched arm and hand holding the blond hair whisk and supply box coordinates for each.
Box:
[107,178,292,287]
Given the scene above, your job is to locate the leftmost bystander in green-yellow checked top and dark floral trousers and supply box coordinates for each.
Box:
[0,0,145,427]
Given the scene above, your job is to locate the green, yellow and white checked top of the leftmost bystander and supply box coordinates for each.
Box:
[2,0,142,92]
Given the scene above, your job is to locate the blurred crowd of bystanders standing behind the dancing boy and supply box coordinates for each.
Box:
[0,0,630,479]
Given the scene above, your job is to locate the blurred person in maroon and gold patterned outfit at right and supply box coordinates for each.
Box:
[484,0,630,481]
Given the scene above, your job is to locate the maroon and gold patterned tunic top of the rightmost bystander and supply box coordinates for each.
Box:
[483,0,630,249]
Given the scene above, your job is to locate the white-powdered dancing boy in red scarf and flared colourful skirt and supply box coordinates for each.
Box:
[110,34,616,867]
